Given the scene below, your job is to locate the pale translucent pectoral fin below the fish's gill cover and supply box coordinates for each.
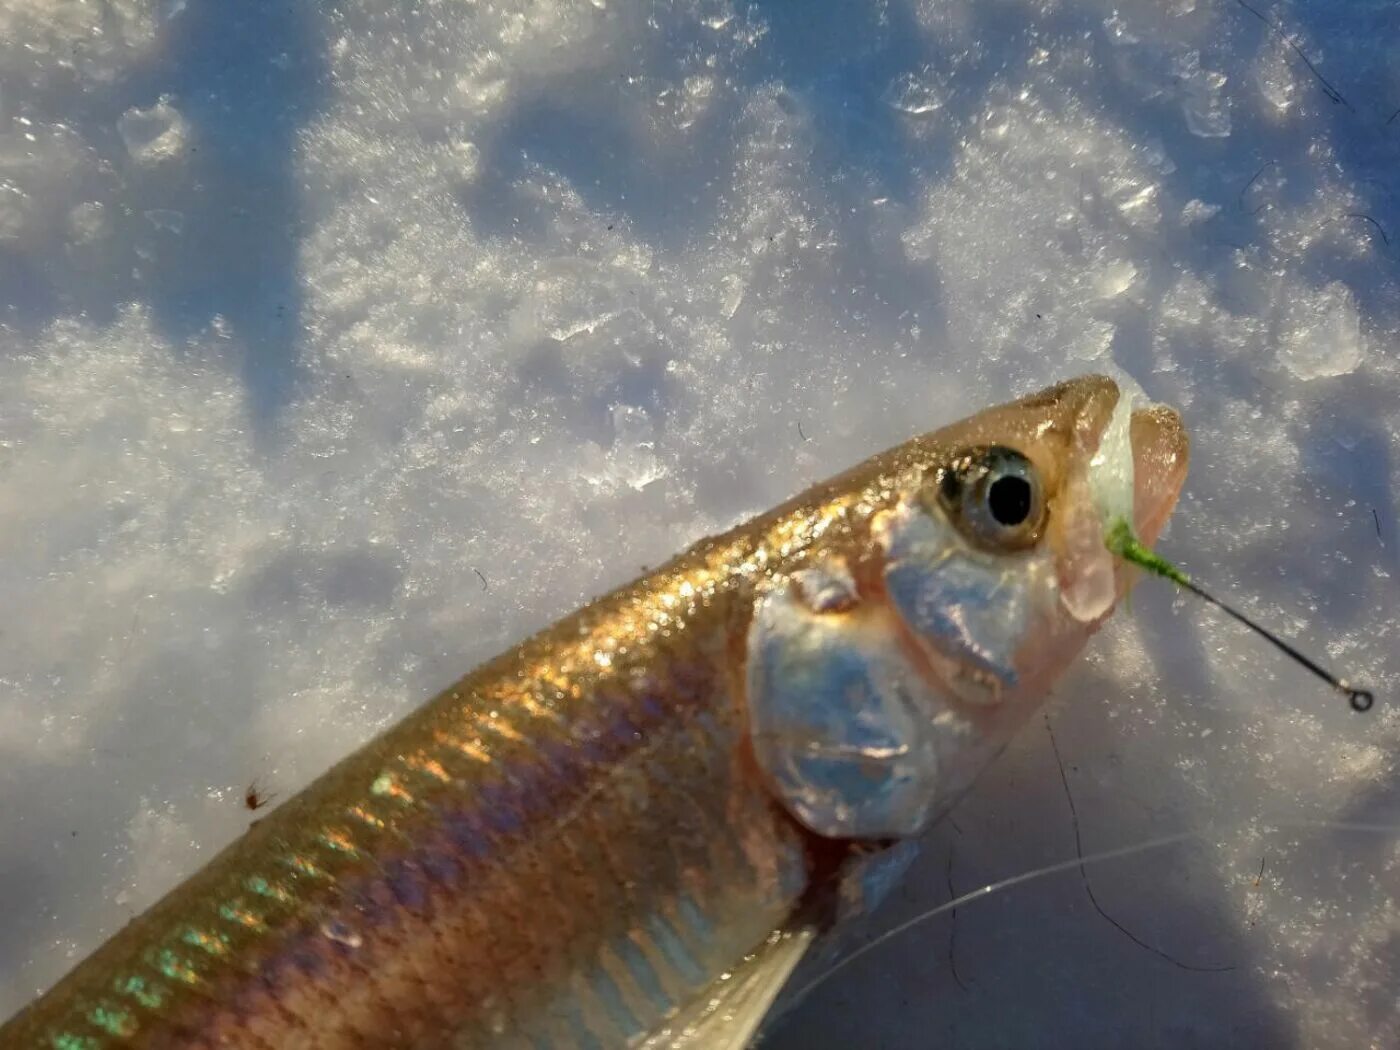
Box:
[638,925,816,1050]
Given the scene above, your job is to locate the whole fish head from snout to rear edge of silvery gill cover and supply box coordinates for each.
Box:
[748,377,1187,837]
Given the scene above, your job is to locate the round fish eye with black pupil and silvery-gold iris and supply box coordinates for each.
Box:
[937,445,1046,550]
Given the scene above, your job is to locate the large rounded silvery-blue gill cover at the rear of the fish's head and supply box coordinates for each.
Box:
[745,566,939,839]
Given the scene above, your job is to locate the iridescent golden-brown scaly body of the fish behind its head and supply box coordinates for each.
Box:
[3,534,805,1050]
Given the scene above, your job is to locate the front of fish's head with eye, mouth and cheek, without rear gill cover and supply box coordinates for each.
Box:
[872,375,1189,707]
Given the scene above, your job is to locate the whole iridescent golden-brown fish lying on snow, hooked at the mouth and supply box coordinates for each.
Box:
[0,375,1189,1050]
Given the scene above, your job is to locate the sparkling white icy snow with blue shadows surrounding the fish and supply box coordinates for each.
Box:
[0,0,1400,1049]
